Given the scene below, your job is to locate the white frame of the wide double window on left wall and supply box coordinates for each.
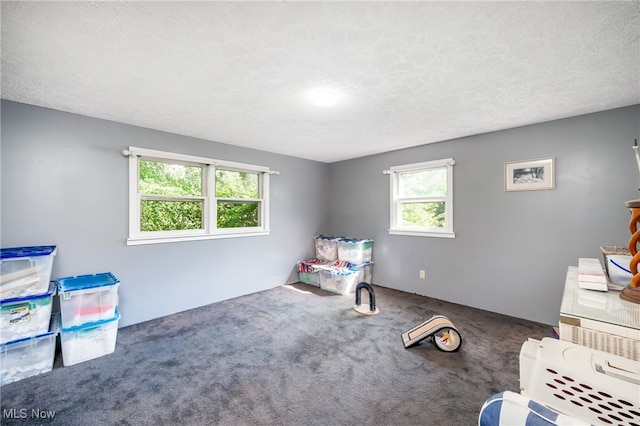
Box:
[127,147,270,245]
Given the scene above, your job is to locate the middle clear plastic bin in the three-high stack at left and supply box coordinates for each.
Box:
[0,281,55,344]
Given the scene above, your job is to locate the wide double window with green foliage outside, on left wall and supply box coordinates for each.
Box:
[127,147,269,245]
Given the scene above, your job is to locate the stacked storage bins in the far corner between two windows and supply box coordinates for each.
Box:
[298,235,373,294]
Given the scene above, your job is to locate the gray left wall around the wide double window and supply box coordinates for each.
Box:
[0,101,328,326]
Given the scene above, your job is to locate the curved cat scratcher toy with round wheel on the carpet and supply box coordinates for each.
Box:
[402,315,462,352]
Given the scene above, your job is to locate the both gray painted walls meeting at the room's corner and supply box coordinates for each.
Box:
[0,101,640,326]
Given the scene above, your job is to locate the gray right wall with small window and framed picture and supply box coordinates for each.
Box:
[327,105,640,324]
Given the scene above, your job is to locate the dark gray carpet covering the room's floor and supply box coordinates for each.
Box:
[0,284,552,426]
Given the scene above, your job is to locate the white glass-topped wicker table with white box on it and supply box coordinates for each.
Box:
[559,266,640,361]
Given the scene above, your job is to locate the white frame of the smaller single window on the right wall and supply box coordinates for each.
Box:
[385,158,455,238]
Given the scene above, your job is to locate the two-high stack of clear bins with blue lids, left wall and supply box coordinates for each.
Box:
[57,272,120,366]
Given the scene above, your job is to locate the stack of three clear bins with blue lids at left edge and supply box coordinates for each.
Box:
[0,246,58,386]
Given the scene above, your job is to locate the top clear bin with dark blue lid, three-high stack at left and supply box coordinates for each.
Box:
[0,246,57,299]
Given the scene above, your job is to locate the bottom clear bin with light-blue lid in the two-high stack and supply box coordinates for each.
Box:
[60,308,120,366]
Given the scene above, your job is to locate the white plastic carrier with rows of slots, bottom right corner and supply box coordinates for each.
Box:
[520,337,640,425]
